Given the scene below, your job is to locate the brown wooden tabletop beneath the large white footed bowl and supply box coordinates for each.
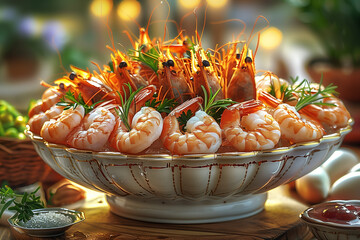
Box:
[0,186,313,240]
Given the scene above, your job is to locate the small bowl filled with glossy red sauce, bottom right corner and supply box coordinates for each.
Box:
[300,200,360,240]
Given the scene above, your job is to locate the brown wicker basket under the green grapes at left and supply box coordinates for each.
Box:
[0,137,51,188]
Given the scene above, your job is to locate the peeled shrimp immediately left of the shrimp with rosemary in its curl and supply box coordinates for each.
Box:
[67,107,115,151]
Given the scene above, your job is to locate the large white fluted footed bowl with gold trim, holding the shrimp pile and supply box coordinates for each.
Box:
[27,124,351,223]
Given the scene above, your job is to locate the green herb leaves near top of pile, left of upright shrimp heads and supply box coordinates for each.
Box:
[129,45,160,74]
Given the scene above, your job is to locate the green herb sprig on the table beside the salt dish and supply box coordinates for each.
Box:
[0,186,44,222]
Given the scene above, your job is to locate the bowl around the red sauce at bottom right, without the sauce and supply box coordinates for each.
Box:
[300,200,360,240]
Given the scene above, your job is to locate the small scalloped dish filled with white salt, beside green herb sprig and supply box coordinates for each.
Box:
[8,208,85,237]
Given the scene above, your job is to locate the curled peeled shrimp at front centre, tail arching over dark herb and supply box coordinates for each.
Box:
[160,97,222,155]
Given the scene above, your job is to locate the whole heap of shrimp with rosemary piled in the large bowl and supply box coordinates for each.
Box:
[28,15,351,155]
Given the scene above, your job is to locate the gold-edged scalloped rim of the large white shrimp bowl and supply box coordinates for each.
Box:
[25,119,354,161]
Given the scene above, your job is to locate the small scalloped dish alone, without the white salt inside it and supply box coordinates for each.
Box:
[8,208,85,237]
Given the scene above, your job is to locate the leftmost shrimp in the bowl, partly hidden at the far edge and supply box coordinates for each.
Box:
[28,105,64,135]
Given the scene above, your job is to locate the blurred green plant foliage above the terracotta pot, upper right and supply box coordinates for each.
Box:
[286,0,360,67]
